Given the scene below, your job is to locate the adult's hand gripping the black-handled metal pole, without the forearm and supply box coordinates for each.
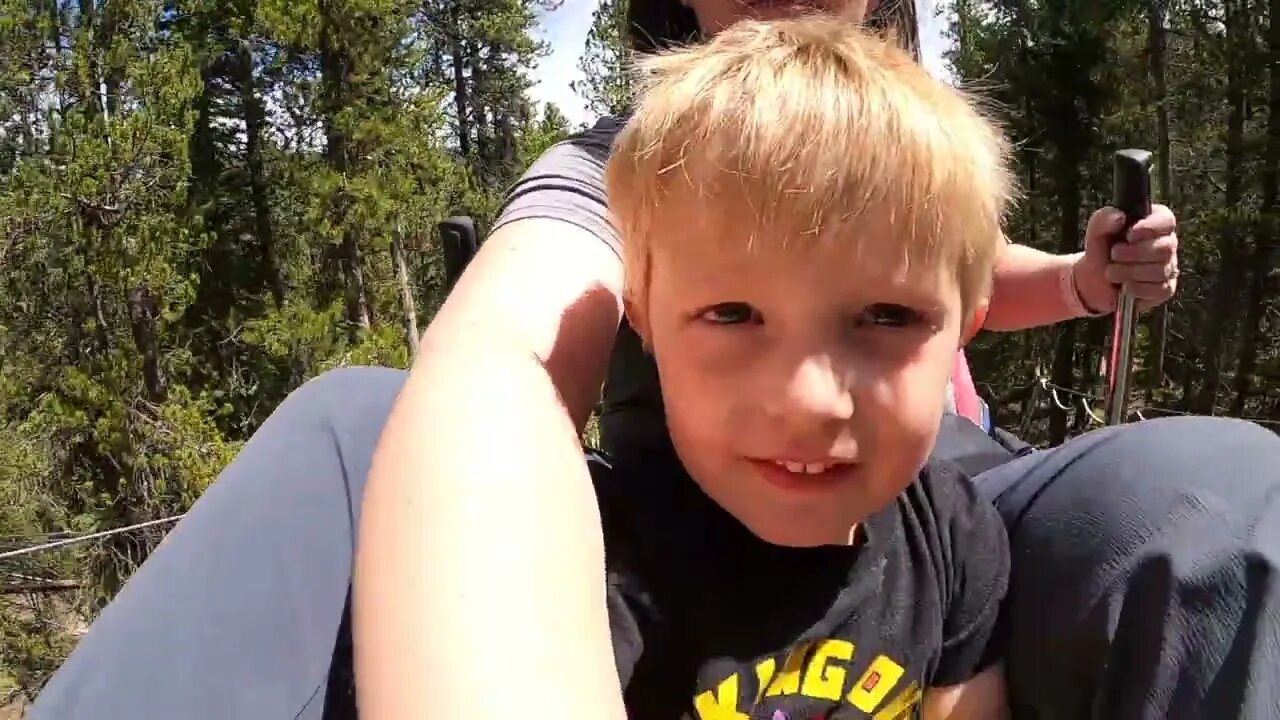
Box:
[1073,205,1178,314]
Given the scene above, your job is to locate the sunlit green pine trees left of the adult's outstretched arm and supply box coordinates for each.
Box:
[0,0,567,706]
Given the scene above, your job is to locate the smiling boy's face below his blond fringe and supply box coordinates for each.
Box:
[640,215,964,546]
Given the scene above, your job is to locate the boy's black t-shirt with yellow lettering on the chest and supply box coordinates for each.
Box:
[593,450,1009,720]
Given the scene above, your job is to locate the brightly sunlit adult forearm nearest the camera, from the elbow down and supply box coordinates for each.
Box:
[353,333,625,720]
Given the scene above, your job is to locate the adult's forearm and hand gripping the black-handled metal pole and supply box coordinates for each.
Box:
[984,205,1178,331]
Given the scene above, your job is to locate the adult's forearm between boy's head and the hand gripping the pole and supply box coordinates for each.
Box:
[983,245,1083,331]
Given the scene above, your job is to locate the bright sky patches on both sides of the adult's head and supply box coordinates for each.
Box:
[532,0,947,126]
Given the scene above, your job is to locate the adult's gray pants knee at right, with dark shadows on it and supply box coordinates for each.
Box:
[978,418,1280,720]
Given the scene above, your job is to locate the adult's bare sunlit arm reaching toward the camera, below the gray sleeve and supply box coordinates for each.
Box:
[353,121,625,720]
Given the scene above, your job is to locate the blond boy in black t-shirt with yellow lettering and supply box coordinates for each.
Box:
[594,12,1011,720]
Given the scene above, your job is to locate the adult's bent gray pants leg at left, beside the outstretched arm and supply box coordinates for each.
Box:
[28,368,404,720]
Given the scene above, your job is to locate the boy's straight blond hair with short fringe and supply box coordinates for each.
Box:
[605,15,1012,325]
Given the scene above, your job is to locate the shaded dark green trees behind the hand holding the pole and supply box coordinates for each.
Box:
[950,0,1280,443]
